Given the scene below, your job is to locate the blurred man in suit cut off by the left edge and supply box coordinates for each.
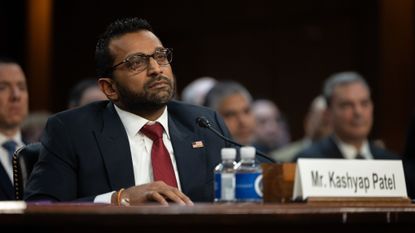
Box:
[0,58,29,200]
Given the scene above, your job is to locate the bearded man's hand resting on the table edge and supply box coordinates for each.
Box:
[111,181,193,205]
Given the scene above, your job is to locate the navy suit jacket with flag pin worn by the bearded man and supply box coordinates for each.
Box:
[24,101,234,202]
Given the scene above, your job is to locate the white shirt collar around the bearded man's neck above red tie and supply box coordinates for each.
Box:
[114,104,170,138]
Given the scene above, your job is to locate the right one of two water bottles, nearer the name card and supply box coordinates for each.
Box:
[235,146,262,202]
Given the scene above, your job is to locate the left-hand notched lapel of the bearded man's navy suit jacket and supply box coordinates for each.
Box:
[95,103,135,190]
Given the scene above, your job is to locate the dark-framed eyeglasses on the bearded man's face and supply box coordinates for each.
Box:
[111,48,173,73]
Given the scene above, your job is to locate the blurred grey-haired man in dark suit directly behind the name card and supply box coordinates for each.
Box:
[297,72,399,159]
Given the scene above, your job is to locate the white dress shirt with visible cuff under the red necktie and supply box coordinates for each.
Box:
[94,105,181,203]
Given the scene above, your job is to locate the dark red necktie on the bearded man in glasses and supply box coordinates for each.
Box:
[140,122,177,188]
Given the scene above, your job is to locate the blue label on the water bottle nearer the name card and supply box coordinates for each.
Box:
[235,173,262,201]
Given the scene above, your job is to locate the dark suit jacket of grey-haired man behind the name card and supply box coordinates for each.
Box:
[297,136,399,159]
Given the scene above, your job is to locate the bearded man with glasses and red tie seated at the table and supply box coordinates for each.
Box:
[25,18,229,205]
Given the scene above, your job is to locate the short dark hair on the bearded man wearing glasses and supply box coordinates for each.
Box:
[95,18,153,78]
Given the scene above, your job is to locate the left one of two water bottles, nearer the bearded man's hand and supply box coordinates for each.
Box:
[214,148,236,202]
